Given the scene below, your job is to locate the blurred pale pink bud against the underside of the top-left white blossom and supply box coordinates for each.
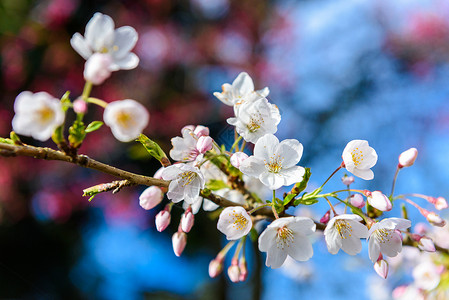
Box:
[84,52,112,85]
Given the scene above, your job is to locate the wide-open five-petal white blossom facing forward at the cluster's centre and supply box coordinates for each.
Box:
[240,134,305,190]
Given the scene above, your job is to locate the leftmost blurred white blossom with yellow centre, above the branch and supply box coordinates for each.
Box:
[12,91,65,141]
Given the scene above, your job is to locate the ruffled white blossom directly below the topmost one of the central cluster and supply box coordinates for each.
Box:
[227,98,281,143]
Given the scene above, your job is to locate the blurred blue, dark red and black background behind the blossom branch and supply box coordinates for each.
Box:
[0,0,449,299]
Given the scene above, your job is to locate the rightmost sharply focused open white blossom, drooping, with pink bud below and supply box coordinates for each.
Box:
[368,218,412,262]
